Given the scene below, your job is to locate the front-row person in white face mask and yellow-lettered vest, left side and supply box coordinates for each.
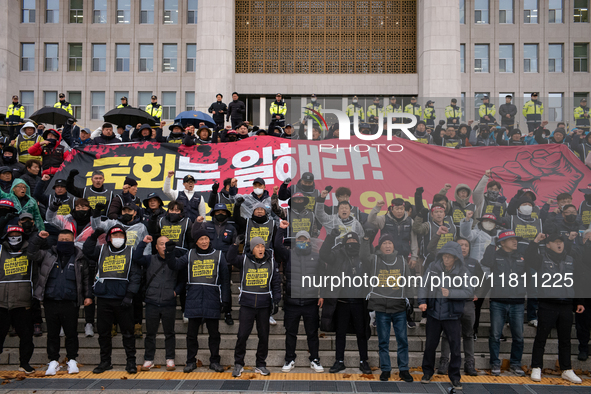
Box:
[83,226,141,374]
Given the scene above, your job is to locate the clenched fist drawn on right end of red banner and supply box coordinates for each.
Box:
[491,149,584,201]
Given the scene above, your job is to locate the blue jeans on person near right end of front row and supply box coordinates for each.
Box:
[488,301,524,368]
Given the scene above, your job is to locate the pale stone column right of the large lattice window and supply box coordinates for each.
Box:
[417,0,461,100]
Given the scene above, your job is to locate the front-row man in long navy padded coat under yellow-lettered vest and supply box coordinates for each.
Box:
[168,229,231,373]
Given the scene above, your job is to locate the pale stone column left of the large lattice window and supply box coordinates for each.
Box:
[195,0,240,111]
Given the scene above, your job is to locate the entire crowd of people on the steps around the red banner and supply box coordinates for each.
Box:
[0,93,591,388]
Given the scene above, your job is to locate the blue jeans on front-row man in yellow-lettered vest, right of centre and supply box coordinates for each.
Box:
[376,311,409,372]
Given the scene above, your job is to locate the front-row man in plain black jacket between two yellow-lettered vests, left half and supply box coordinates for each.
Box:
[133,235,183,371]
